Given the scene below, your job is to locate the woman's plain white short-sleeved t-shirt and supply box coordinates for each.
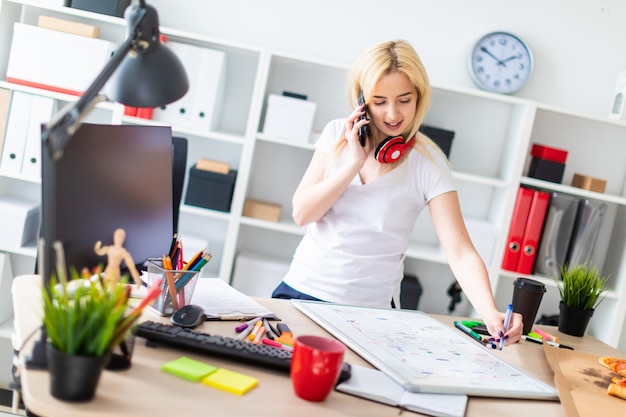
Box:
[284,119,456,307]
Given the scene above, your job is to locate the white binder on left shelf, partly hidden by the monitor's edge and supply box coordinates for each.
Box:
[21,96,55,179]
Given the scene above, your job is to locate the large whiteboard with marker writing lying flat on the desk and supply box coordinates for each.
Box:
[292,300,558,400]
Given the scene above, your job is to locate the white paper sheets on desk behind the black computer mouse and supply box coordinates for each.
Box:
[191,278,280,320]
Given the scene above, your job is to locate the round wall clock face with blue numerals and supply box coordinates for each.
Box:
[469,32,533,94]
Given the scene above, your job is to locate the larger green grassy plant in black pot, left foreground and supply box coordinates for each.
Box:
[42,247,161,401]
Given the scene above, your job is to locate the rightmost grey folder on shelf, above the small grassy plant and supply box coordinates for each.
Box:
[567,199,607,268]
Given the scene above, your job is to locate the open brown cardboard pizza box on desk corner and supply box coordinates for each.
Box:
[543,344,626,417]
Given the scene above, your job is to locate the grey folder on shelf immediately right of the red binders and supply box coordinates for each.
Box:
[534,192,580,278]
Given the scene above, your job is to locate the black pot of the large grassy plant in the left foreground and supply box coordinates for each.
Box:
[46,345,109,402]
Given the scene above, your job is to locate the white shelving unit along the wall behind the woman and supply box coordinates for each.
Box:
[0,0,626,386]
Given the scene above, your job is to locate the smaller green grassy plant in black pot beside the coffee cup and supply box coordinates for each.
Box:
[556,263,609,336]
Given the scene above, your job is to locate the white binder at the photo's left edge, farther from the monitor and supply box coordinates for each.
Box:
[0,91,33,175]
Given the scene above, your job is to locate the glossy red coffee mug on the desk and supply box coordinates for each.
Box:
[291,335,346,401]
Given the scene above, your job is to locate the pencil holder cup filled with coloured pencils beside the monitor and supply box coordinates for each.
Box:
[148,259,200,316]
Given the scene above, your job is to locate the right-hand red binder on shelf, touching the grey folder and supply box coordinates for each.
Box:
[517,190,550,274]
